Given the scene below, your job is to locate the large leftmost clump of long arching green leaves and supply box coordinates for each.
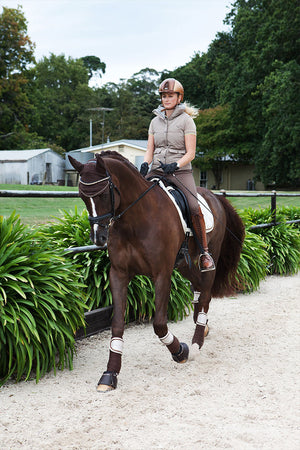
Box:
[0,214,85,385]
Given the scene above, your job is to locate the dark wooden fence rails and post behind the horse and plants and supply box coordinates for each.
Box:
[0,190,300,339]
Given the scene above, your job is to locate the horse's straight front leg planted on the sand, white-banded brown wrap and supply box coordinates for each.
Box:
[97,268,129,392]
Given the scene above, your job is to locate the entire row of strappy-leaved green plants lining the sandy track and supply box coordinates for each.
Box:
[0,208,300,385]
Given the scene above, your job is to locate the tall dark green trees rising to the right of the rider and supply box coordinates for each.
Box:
[168,0,300,186]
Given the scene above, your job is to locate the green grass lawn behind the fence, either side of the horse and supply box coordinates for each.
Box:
[0,184,300,224]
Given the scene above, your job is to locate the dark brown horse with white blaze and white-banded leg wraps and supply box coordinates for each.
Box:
[69,152,244,391]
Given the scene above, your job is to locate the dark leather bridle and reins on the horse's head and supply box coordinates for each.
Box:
[79,170,159,229]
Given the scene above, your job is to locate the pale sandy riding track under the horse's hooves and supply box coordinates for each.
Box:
[0,273,300,450]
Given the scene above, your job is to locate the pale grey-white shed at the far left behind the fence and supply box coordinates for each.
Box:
[0,148,65,184]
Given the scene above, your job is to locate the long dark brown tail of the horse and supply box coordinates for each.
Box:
[212,195,245,297]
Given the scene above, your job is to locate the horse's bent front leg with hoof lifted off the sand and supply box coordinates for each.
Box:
[153,275,189,363]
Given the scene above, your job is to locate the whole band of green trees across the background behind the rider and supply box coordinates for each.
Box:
[0,0,300,187]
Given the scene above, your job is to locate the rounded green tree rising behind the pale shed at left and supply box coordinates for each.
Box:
[27,54,94,150]
